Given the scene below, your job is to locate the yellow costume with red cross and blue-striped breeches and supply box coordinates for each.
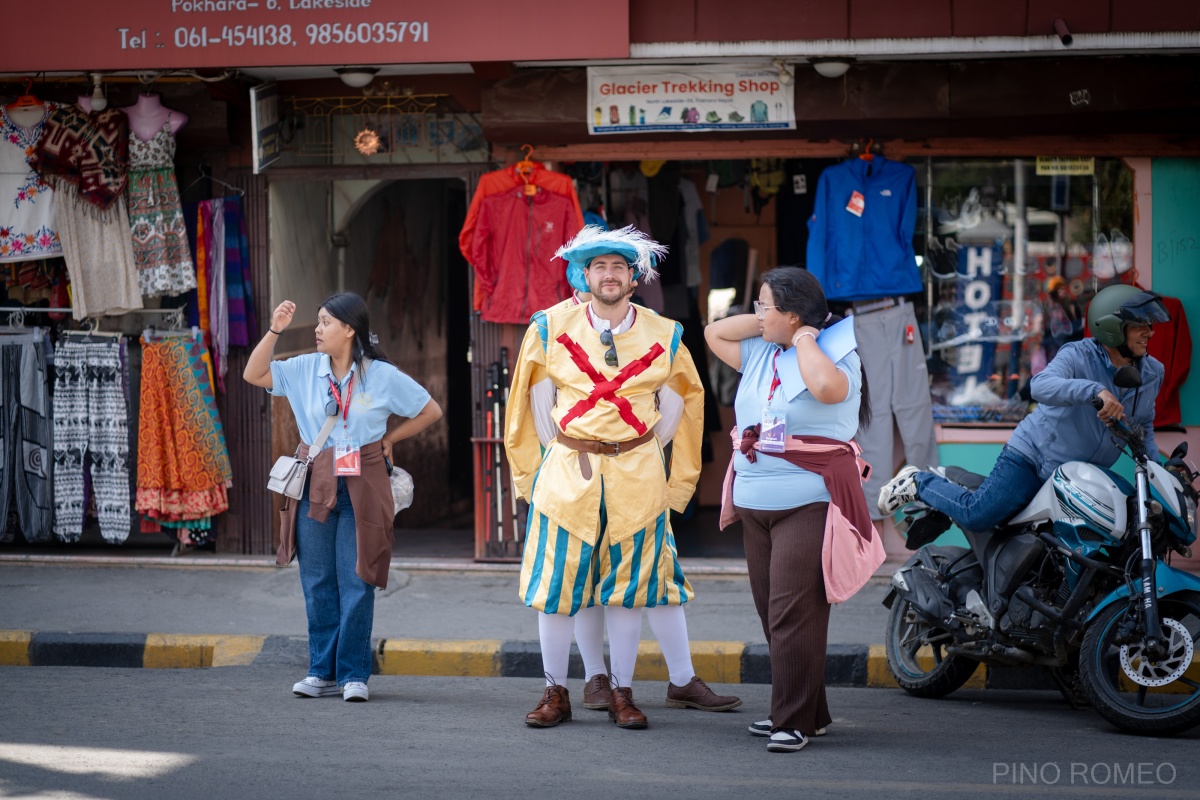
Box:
[504,305,704,614]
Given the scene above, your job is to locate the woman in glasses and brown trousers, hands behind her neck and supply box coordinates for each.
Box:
[704,266,878,752]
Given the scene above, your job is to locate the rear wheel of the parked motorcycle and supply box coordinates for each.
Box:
[887,597,979,697]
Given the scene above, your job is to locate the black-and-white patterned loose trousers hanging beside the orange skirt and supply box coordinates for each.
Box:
[54,339,132,545]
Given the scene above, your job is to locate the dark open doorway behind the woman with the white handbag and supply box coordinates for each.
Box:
[270,178,473,558]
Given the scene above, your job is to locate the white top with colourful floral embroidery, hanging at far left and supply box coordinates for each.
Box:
[0,103,62,263]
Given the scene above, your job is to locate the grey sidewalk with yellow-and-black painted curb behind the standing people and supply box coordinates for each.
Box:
[0,555,1032,686]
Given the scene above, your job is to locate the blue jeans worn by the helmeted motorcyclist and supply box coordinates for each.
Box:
[916,446,1043,531]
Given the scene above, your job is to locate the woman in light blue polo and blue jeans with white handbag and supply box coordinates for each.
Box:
[244,293,442,702]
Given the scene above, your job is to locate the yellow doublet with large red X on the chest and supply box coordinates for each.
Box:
[504,305,704,546]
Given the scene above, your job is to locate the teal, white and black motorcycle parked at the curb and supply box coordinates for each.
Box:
[883,367,1200,735]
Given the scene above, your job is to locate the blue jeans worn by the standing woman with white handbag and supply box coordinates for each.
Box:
[296,477,374,686]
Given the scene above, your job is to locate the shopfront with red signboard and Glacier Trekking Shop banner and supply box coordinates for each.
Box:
[0,0,1200,568]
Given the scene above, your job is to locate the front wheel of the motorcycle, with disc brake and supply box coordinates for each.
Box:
[1079,591,1200,736]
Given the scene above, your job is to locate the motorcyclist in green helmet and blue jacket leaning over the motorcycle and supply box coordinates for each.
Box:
[878,284,1170,530]
